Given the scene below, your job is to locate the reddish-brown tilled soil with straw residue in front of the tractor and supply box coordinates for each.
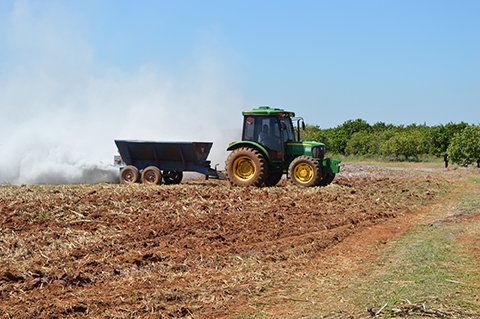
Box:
[0,165,448,318]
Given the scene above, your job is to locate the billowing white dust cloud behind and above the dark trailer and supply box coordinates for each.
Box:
[0,2,244,184]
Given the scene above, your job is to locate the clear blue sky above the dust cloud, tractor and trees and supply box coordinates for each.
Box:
[0,0,480,127]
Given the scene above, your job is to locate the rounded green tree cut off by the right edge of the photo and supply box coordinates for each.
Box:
[448,125,480,167]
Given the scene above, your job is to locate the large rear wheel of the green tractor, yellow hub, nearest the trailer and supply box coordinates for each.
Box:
[225,147,268,187]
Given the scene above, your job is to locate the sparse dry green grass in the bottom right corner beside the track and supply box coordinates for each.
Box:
[357,188,480,318]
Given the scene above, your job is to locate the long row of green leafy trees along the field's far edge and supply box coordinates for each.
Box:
[303,119,480,167]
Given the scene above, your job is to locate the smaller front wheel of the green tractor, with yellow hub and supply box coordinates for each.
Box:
[288,155,322,187]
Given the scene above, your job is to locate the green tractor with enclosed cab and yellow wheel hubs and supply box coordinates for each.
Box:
[225,106,340,187]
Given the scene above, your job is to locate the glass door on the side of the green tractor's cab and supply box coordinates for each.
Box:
[242,115,285,161]
